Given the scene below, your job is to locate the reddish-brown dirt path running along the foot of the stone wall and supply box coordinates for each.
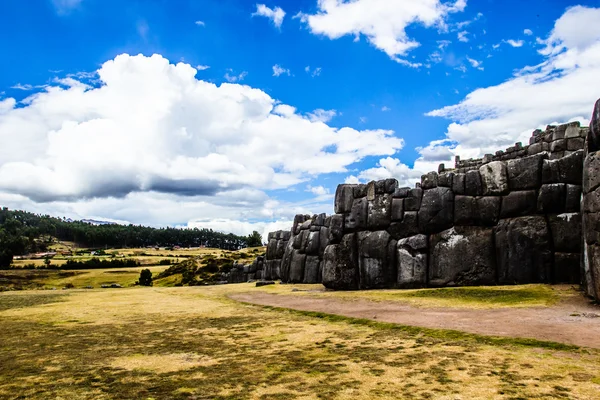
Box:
[230,292,600,348]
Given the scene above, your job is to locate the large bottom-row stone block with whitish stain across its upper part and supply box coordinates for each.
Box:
[429,226,496,286]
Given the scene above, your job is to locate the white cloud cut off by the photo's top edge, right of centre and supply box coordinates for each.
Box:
[297,0,466,67]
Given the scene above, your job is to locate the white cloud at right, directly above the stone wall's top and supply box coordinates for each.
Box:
[422,6,600,167]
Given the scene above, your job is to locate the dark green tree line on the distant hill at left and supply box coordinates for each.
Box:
[0,207,262,267]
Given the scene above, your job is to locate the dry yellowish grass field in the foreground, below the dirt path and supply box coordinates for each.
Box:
[0,282,600,399]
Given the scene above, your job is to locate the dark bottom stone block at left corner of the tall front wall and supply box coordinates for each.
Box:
[323,233,359,290]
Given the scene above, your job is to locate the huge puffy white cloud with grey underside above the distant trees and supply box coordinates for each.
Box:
[0,54,403,231]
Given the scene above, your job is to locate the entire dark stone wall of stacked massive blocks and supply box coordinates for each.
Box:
[252,101,600,297]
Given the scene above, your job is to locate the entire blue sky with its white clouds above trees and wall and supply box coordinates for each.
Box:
[0,0,600,238]
